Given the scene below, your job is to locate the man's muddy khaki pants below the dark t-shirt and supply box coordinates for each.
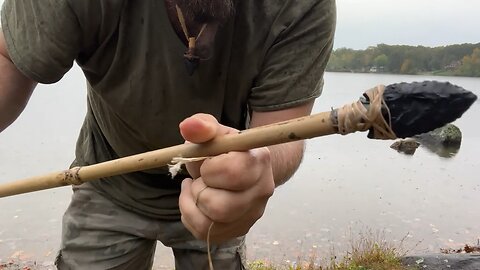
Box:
[55,184,246,270]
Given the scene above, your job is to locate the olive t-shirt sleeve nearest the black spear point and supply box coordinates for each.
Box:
[249,0,336,111]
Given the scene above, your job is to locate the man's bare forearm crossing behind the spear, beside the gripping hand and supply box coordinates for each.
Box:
[250,101,314,186]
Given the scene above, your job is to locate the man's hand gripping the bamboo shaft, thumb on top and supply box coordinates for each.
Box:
[179,114,275,242]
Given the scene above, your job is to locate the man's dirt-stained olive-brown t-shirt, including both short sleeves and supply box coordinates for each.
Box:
[1,0,335,219]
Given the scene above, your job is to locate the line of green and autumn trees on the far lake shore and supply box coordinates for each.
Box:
[327,43,480,77]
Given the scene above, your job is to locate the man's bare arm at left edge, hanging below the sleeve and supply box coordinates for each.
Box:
[0,29,37,132]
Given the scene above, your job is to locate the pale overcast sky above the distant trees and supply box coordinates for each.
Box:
[0,0,480,49]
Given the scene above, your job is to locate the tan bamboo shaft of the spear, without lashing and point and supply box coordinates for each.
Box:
[0,109,337,198]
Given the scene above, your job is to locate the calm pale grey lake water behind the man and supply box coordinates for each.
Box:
[0,68,480,269]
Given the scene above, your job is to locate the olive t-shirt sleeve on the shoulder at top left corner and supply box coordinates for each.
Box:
[1,0,81,83]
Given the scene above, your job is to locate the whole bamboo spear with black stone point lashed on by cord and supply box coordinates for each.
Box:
[0,81,477,198]
